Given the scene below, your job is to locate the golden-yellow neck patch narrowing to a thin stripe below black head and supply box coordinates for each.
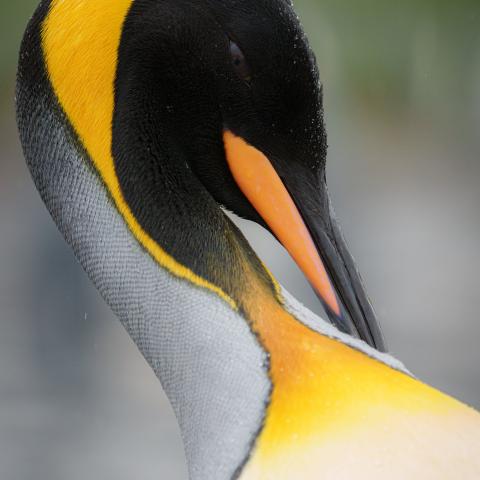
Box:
[42,0,237,309]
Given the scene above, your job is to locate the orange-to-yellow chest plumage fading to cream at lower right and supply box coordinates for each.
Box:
[240,284,480,480]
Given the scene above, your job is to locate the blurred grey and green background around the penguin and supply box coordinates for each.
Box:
[0,0,480,480]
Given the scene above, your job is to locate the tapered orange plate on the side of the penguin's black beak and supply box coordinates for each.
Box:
[223,130,341,316]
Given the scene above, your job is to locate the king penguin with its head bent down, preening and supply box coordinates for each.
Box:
[17,0,480,480]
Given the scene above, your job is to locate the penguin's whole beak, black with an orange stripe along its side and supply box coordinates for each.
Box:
[223,130,385,350]
